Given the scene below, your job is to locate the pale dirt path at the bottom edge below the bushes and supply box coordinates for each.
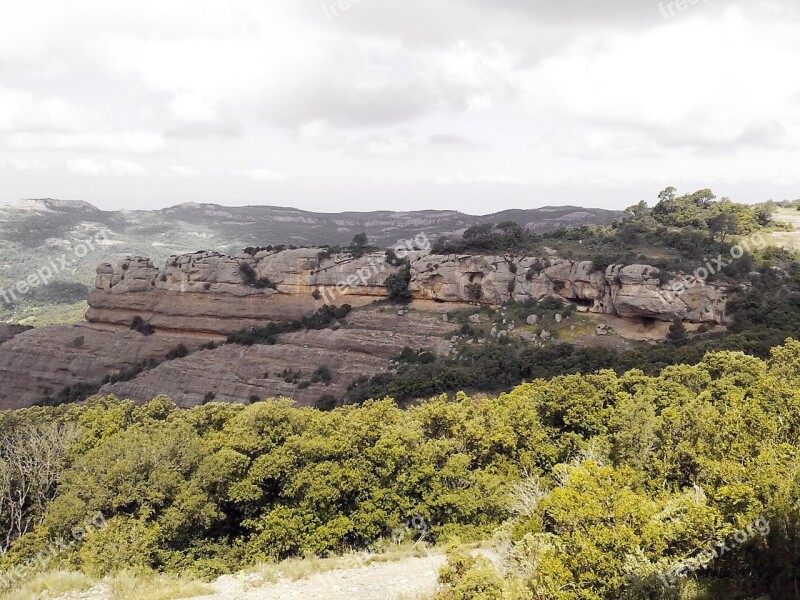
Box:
[195,554,445,600]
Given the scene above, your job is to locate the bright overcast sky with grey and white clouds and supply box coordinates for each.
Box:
[0,0,800,214]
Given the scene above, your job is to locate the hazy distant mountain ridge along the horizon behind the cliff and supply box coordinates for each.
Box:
[0,198,623,315]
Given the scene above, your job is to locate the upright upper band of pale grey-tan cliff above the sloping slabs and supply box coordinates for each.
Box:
[87,249,726,335]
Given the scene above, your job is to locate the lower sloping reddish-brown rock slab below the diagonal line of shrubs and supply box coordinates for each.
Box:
[100,308,452,407]
